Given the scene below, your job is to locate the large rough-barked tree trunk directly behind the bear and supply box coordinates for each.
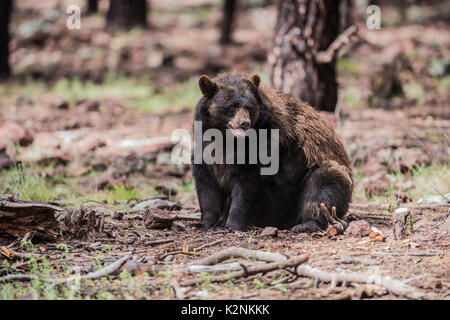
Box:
[268,0,350,112]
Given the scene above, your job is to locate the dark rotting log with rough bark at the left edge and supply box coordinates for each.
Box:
[0,196,63,241]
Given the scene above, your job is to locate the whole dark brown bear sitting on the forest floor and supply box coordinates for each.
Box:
[192,74,353,232]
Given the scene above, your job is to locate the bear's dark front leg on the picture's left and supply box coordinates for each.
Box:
[192,165,223,230]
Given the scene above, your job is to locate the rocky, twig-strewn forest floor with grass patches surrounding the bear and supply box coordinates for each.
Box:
[0,0,450,299]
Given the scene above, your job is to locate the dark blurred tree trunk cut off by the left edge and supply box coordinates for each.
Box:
[0,0,12,78]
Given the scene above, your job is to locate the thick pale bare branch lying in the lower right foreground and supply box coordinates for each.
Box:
[296,265,431,299]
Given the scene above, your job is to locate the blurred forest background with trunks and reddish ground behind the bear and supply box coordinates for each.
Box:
[0,0,450,298]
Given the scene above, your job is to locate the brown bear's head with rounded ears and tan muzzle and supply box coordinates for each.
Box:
[199,74,261,137]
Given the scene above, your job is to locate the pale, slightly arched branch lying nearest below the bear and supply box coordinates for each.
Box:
[190,247,286,266]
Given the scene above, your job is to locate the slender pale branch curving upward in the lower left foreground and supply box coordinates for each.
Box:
[0,255,131,285]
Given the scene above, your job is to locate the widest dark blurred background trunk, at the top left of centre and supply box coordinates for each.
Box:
[106,0,147,29]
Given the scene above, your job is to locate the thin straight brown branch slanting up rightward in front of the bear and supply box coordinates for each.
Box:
[180,255,309,287]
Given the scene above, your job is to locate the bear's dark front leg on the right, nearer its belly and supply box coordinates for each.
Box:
[225,184,256,231]
